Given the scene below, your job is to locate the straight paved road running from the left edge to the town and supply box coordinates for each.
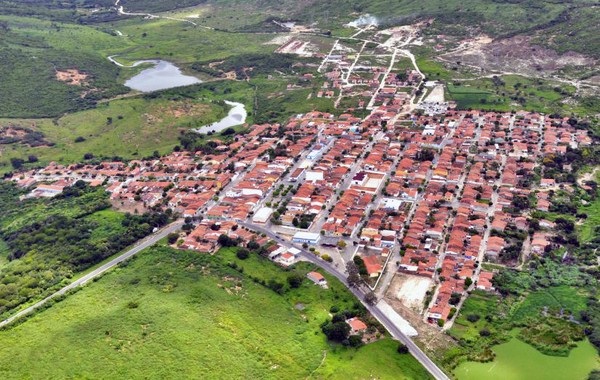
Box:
[0,220,183,327]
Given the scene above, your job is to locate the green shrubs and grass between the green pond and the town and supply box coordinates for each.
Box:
[444,254,600,368]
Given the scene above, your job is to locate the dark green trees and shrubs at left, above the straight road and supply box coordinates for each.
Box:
[0,182,168,317]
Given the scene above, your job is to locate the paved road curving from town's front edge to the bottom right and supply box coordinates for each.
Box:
[238,222,449,380]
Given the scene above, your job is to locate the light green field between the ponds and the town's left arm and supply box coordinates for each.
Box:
[0,97,227,172]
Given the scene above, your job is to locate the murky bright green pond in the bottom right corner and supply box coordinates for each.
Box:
[454,331,600,380]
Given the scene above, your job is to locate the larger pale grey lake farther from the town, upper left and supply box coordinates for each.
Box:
[122,60,202,92]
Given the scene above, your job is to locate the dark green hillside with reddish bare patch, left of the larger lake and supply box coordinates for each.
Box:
[0,16,132,117]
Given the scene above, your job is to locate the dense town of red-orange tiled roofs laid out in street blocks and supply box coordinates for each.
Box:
[11,98,591,328]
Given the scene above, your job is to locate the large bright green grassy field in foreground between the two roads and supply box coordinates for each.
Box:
[0,247,428,379]
